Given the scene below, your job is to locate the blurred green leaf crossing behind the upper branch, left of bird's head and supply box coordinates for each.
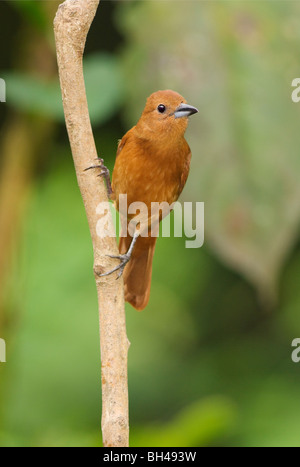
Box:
[3,54,123,124]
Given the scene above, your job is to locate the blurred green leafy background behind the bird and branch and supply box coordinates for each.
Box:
[0,0,300,447]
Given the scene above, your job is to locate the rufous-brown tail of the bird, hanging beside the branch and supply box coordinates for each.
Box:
[119,235,157,311]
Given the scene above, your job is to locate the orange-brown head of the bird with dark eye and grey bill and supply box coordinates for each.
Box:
[136,90,198,143]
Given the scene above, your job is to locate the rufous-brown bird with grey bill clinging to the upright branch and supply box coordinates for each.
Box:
[103,90,198,310]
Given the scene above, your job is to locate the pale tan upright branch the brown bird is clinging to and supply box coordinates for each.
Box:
[54,0,129,447]
